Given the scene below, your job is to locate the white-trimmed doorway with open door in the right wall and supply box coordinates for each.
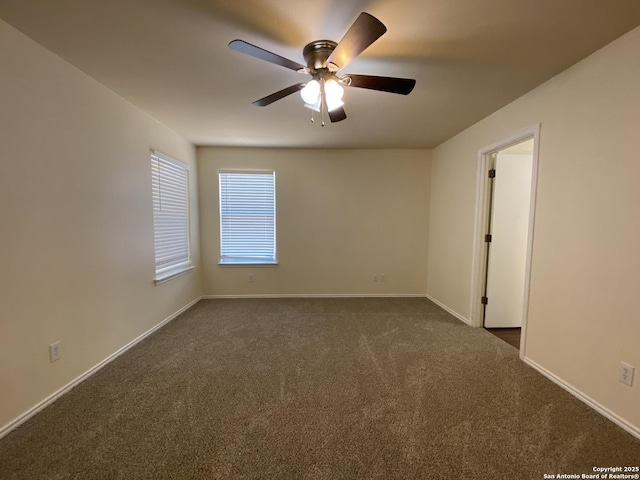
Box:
[471,126,539,357]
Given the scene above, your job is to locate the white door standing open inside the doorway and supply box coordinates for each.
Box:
[484,144,533,328]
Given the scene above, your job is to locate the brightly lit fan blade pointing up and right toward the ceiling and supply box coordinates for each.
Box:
[327,12,387,69]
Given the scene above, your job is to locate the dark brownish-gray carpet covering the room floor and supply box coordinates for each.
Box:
[0,298,640,480]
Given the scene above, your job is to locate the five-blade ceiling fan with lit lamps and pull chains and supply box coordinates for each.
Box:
[229,12,416,126]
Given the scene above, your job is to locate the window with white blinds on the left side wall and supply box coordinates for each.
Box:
[151,151,194,284]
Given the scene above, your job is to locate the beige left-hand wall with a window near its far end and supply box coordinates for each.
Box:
[0,22,201,429]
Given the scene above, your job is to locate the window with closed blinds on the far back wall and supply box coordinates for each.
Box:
[218,170,276,265]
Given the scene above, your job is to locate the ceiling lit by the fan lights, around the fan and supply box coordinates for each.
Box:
[0,0,640,148]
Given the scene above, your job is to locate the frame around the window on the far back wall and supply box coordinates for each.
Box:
[218,169,278,267]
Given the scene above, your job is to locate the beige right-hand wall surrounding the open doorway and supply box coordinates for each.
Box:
[428,28,640,432]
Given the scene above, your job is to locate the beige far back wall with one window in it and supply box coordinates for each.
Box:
[198,147,430,295]
